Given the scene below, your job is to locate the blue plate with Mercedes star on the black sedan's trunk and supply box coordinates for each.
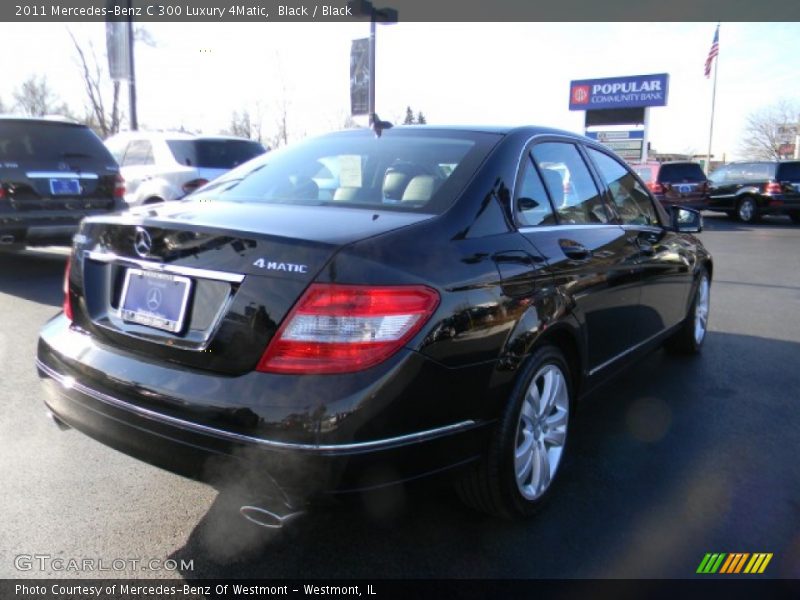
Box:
[119,269,192,333]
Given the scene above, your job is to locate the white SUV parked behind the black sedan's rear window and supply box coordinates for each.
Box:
[101,131,266,206]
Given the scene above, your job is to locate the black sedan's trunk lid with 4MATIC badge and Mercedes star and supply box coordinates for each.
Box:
[70,201,430,374]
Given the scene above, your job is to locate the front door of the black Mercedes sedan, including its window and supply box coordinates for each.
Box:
[587,147,691,344]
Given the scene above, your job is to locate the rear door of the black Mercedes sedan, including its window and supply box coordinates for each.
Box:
[516,138,639,372]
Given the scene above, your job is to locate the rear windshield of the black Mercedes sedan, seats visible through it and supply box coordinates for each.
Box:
[191,130,500,214]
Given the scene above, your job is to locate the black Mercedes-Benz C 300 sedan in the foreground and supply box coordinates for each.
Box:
[37,127,713,525]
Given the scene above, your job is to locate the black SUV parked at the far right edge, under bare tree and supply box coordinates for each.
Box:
[708,160,800,223]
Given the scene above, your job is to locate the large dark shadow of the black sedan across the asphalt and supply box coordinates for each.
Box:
[170,332,800,580]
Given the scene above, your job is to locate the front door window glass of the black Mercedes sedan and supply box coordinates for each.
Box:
[588,148,658,225]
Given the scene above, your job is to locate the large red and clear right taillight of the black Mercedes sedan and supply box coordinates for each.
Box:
[256,283,439,374]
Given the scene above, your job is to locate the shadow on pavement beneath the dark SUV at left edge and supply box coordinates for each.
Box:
[0,252,67,306]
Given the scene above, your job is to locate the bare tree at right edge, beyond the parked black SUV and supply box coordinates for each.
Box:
[741,100,800,160]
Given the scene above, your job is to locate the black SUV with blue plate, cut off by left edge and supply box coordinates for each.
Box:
[0,117,125,249]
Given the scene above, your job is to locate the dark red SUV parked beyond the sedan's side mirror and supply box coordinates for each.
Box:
[633,161,708,210]
